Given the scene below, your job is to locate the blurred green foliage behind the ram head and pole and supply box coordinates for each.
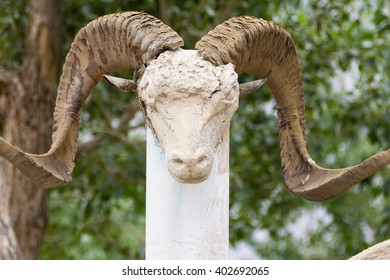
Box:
[0,0,390,259]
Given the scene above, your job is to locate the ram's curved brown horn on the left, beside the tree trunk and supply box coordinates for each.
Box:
[0,12,183,188]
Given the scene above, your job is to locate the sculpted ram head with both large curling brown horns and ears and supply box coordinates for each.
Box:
[0,12,390,200]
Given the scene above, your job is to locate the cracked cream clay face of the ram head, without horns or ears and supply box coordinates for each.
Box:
[137,49,240,183]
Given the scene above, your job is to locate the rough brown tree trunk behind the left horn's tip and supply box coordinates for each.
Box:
[0,0,62,259]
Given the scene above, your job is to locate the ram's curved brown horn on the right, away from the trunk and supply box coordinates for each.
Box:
[196,17,390,201]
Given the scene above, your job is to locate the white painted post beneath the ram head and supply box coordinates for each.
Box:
[146,128,229,260]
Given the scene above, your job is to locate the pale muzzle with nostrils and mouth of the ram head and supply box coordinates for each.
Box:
[168,149,213,184]
